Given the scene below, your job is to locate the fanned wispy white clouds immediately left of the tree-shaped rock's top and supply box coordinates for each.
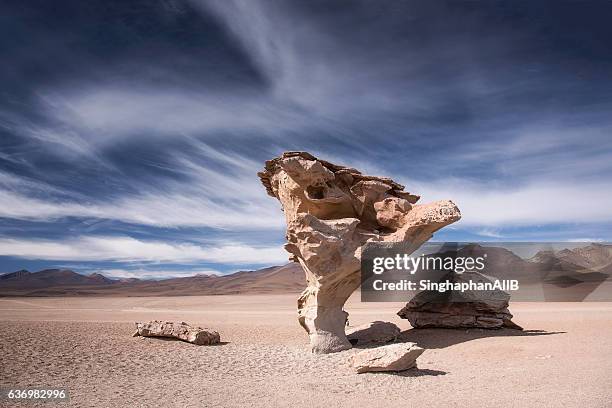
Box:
[0,141,284,230]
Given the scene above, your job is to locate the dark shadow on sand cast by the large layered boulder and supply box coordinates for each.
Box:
[397,328,566,349]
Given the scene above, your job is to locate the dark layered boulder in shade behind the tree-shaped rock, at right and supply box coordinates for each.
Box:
[397,272,522,330]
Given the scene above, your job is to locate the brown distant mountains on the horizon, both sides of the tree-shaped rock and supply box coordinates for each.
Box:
[0,244,612,296]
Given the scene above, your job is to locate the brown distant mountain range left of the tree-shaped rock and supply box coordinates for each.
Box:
[0,263,306,296]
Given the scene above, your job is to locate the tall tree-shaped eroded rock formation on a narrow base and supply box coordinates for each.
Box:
[258,152,461,353]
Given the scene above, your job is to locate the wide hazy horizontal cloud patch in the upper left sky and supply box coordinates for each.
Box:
[34,83,314,143]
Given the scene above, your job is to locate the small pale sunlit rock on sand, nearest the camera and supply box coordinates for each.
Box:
[350,343,425,373]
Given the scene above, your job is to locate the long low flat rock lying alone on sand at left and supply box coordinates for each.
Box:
[134,320,221,346]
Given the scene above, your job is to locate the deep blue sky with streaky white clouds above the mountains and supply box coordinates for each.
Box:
[0,0,612,278]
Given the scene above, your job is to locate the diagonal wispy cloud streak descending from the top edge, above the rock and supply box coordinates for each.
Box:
[192,0,424,114]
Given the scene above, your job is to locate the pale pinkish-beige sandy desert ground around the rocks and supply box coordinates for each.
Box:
[0,295,612,408]
